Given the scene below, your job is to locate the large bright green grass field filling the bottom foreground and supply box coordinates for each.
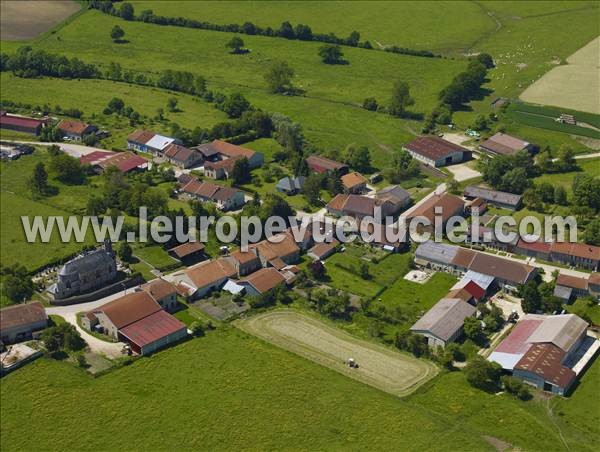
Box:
[0,328,599,451]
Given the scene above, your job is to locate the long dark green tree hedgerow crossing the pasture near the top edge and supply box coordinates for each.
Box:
[90,0,439,58]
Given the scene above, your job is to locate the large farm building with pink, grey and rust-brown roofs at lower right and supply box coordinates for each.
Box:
[488,314,598,395]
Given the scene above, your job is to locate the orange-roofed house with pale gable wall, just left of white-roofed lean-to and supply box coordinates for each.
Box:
[179,258,237,299]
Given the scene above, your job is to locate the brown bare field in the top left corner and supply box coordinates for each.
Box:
[0,0,81,41]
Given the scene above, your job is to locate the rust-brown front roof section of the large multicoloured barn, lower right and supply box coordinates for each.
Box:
[515,343,576,388]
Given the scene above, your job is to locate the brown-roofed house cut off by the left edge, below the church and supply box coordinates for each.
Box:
[0,301,48,344]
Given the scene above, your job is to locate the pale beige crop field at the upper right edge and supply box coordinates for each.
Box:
[521,36,600,114]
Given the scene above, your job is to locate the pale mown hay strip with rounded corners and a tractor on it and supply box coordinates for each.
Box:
[236,310,437,396]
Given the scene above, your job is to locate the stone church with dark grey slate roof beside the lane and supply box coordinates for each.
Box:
[48,241,117,300]
